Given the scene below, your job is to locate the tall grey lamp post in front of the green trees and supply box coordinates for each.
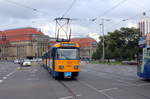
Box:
[99,19,110,61]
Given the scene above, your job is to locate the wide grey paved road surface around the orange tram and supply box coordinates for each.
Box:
[0,63,150,99]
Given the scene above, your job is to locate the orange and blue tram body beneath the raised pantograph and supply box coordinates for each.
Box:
[43,42,80,78]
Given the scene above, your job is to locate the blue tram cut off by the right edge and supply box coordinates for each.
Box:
[137,34,150,79]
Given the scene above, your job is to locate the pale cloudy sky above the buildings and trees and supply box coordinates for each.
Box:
[0,0,150,37]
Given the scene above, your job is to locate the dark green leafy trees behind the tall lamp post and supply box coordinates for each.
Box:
[93,28,141,60]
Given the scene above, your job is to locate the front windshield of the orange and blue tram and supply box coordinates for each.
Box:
[56,49,79,60]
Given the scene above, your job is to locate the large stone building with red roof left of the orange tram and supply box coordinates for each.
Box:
[0,27,49,60]
